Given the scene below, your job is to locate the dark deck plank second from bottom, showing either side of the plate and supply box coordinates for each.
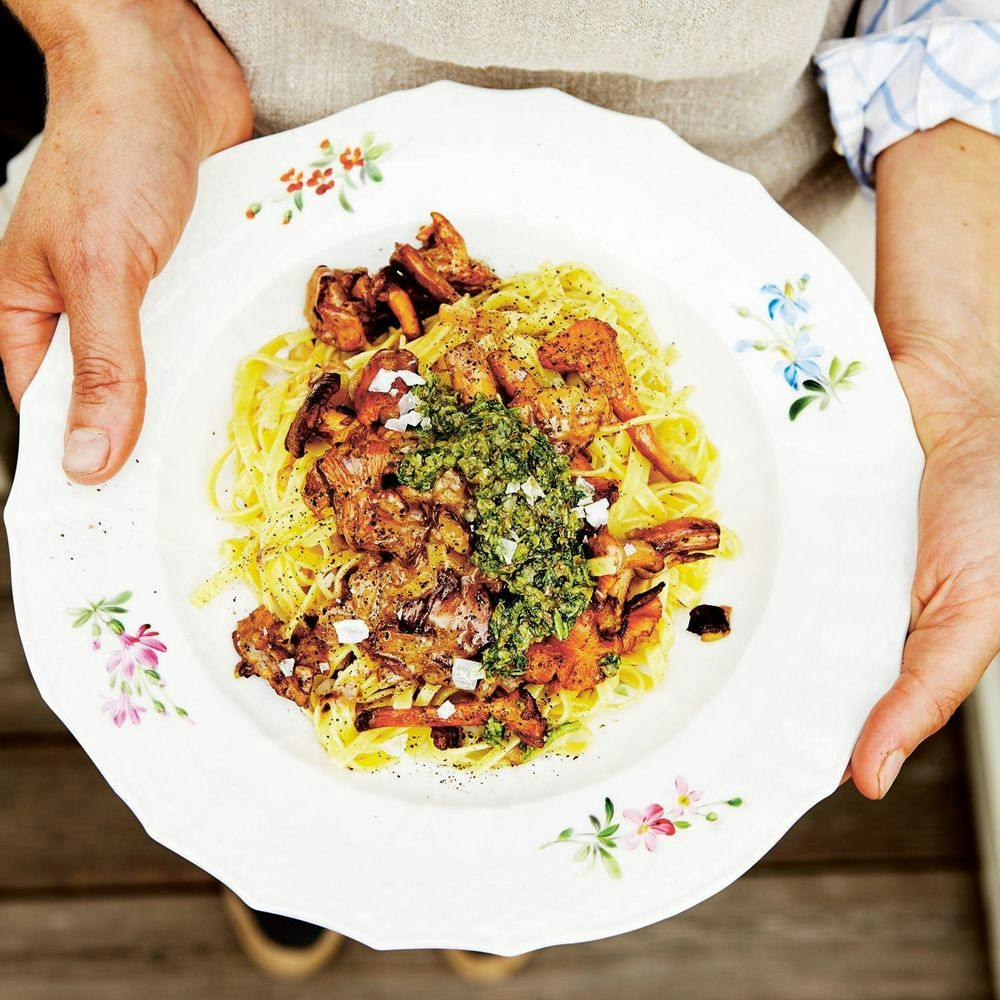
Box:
[0,734,974,892]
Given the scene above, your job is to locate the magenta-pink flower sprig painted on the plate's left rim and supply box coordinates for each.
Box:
[68,590,191,729]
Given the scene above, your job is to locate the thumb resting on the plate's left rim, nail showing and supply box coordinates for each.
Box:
[56,257,147,484]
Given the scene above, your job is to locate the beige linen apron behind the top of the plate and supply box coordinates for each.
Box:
[198,0,853,226]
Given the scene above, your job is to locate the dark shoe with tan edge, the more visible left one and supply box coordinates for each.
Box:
[222,889,344,979]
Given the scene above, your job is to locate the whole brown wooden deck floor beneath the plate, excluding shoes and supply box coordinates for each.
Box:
[0,500,991,1000]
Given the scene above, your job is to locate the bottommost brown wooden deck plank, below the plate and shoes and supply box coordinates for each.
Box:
[0,872,990,1000]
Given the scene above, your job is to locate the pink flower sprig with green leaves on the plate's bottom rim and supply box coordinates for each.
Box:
[541,775,743,878]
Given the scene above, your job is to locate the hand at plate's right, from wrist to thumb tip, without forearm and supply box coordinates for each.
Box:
[851,344,1000,798]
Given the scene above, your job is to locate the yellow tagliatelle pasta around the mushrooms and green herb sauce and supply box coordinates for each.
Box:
[193,263,736,769]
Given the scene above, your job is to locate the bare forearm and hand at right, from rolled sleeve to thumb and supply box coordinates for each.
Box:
[851,122,1000,798]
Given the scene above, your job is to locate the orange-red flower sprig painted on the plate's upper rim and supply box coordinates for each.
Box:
[245,132,391,226]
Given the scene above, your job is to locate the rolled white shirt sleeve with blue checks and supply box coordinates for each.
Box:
[815,0,1000,194]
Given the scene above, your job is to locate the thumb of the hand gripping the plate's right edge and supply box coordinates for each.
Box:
[851,593,1000,799]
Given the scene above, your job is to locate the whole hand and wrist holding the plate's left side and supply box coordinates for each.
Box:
[0,0,251,483]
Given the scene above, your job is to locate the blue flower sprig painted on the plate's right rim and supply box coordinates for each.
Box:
[736,274,864,420]
